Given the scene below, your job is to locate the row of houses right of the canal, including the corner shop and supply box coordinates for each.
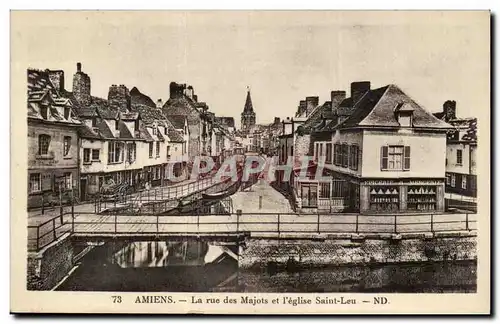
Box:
[276,81,477,213]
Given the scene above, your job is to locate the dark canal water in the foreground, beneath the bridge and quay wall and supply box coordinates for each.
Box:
[56,241,476,293]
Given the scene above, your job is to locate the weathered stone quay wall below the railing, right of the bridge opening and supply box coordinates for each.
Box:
[239,231,477,269]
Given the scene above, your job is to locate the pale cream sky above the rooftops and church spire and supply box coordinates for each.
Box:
[11,11,490,125]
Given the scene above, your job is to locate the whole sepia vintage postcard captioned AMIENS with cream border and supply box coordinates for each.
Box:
[11,11,491,314]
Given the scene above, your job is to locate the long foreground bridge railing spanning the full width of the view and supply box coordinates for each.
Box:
[28,212,477,251]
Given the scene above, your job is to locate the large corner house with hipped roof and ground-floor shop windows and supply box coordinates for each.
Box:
[294,81,451,213]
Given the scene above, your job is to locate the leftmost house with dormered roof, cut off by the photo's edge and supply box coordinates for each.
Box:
[27,69,80,208]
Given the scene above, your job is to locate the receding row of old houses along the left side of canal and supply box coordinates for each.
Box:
[27,63,234,208]
